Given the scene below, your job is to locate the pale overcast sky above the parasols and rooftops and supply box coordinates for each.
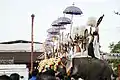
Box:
[0,0,120,52]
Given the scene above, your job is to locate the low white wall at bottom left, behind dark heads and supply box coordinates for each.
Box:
[0,64,29,80]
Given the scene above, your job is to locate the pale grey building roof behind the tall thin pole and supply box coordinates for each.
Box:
[0,40,44,52]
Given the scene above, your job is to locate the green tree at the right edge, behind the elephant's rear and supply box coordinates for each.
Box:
[109,41,120,74]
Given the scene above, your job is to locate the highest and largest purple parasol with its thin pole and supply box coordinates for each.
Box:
[63,4,83,35]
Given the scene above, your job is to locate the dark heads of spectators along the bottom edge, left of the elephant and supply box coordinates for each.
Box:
[0,70,66,80]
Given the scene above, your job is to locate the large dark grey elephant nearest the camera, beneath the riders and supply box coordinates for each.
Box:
[62,57,113,80]
